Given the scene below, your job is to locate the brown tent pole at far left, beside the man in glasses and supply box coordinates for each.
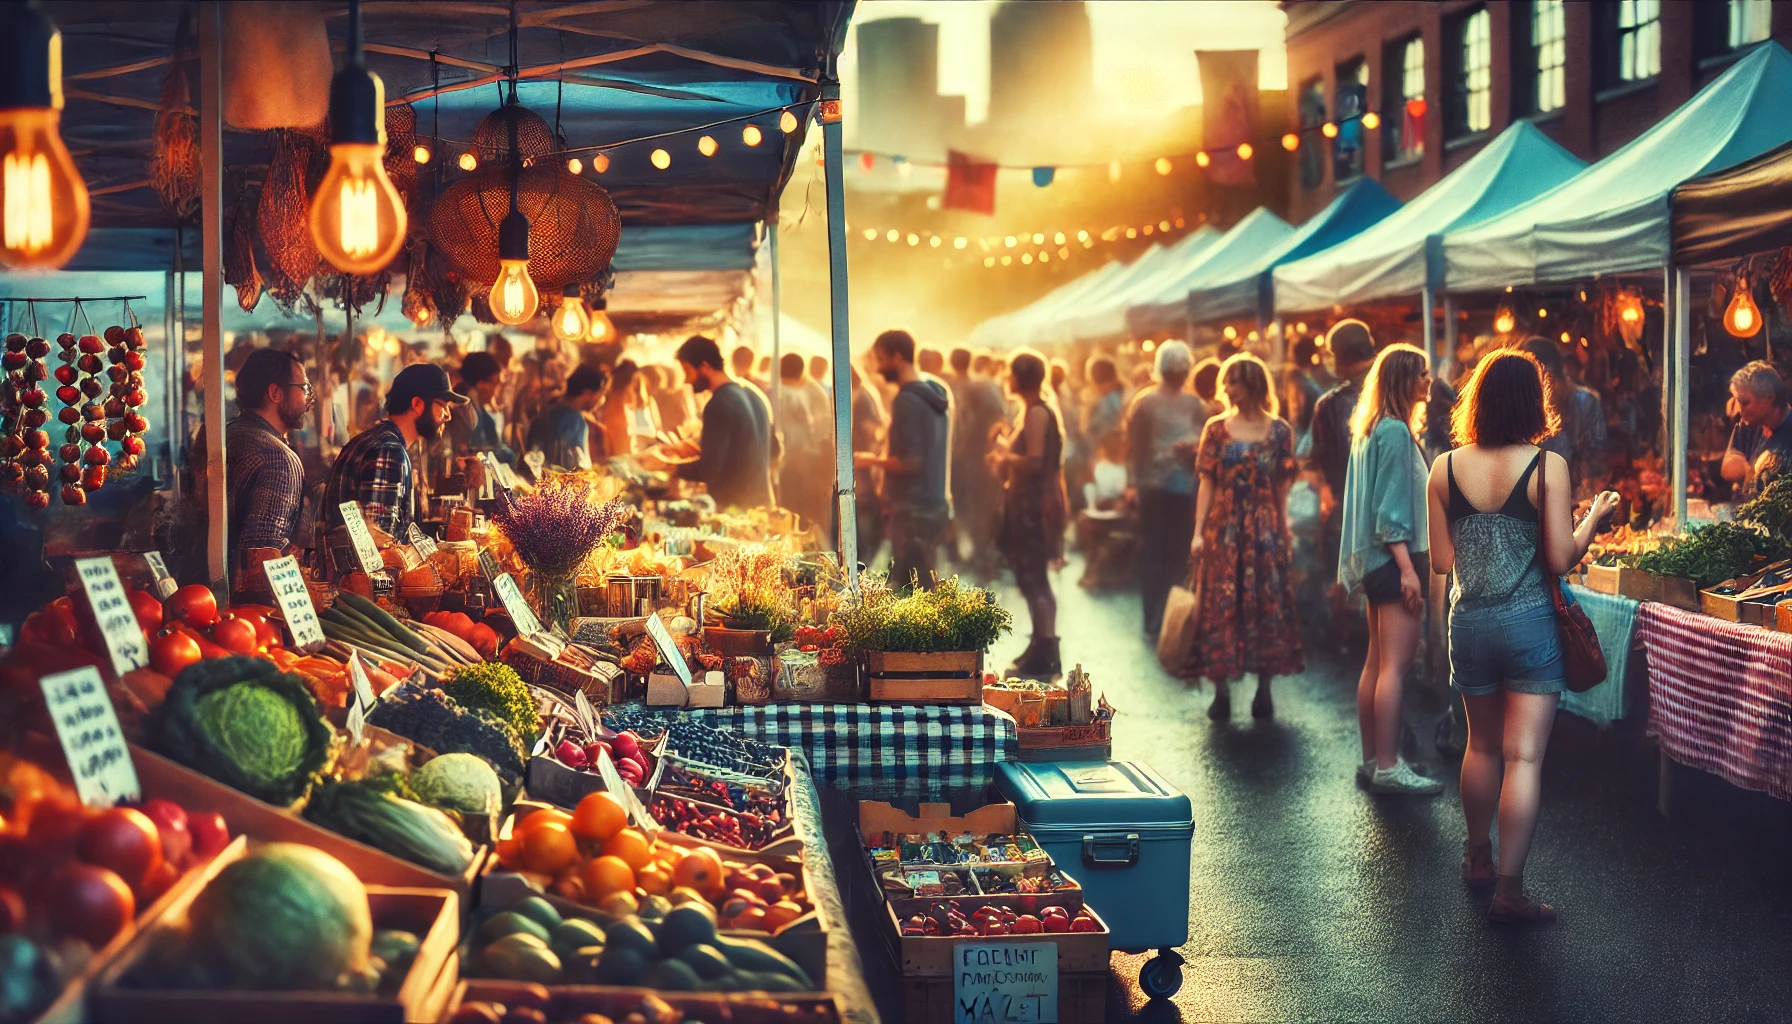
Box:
[199,2,229,595]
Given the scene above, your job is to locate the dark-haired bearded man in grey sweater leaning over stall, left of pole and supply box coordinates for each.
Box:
[663,335,776,509]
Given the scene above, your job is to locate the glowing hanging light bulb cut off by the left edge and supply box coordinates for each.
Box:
[0,4,91,269]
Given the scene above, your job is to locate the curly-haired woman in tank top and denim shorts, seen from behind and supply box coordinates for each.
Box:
[1428,350,1618,924]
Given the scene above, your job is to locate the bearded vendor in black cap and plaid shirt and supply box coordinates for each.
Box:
[323,362,468,545]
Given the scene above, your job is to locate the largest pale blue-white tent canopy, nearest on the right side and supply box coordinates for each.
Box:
[1443,41,1792,291]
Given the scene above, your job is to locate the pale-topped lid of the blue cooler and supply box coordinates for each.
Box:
[996,760,1193,829]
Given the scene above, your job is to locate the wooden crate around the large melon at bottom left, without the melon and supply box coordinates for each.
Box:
[93,845,461,1024]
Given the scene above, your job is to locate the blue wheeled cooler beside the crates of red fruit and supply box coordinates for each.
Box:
[996,760,1195,999]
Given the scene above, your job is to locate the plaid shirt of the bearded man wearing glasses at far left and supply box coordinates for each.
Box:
[224,412,305,570]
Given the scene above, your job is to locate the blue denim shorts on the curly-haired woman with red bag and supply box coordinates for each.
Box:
[1450,601,1568,698]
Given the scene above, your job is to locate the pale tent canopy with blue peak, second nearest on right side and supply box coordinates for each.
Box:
[1276,120,1586,312]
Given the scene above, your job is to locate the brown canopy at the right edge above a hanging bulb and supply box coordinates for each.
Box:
[1672,142,1792,265]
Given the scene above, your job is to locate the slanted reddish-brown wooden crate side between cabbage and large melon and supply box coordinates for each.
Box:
[131,742,487,896]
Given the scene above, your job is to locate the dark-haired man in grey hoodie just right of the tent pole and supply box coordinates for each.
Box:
[853,330,952,588]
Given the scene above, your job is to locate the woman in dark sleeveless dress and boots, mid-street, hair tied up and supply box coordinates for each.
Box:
[989,348,1070,680]
